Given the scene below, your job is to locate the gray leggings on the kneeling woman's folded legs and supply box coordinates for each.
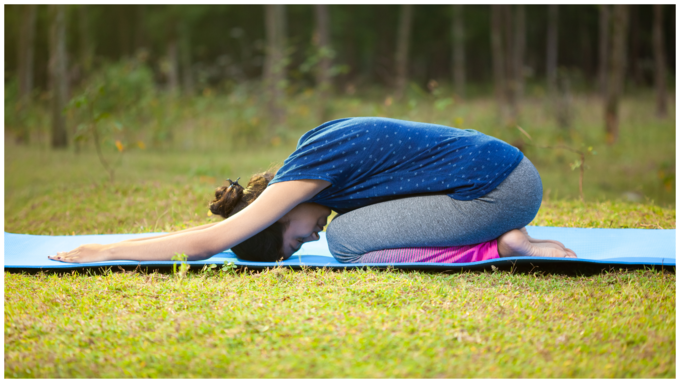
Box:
[326,157,543,263]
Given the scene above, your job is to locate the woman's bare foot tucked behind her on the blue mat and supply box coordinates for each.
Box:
[498,230,576,258]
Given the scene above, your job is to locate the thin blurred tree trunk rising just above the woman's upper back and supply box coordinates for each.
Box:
[314,4,334,122]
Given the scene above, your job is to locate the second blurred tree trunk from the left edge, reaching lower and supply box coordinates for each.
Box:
[48,5,68,148]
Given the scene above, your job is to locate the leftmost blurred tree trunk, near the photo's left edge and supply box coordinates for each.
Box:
[17,4,37,109]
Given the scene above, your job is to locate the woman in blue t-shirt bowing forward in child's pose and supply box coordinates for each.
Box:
[50,117,576,263]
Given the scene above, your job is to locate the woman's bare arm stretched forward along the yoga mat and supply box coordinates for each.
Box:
[49,180,330,263]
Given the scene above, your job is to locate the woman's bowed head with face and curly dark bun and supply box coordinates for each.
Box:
[210,170,330,262]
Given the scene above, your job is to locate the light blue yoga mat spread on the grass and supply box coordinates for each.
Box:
[5,226,675,270]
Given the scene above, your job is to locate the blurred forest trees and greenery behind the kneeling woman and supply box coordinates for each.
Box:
[5,5,675,210]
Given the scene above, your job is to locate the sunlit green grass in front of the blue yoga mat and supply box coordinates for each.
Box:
[5,268,676,378]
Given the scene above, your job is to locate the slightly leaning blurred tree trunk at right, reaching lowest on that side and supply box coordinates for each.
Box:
[605,5,628,145]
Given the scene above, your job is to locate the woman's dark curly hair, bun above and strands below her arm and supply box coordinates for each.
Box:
[210,168,286,262]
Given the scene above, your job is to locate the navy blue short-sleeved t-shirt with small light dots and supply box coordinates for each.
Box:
[269,117,523,213]
